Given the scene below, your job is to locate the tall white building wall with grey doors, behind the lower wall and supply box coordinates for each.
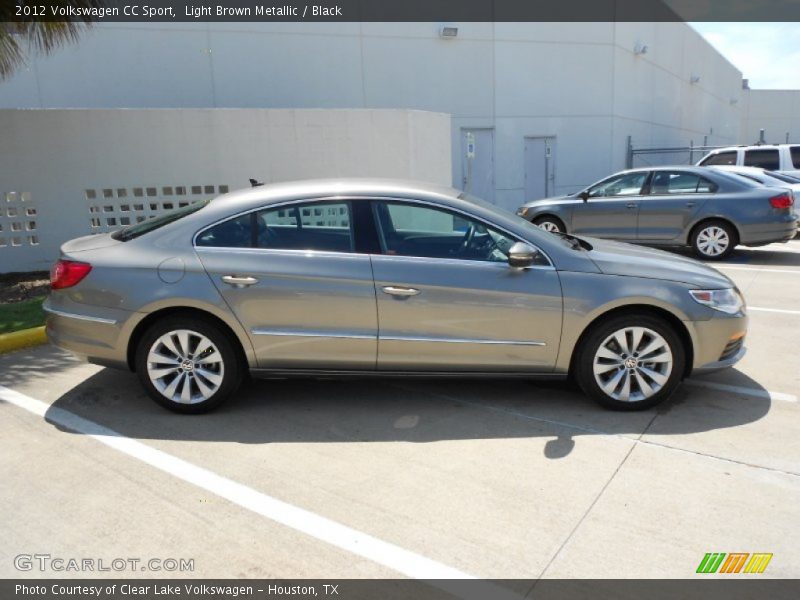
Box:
[0,23,742,209]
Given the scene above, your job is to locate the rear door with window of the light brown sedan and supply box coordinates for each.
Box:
[195,199,378,370]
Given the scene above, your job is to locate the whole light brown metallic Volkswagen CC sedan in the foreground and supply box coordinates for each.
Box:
[45,179,747,413]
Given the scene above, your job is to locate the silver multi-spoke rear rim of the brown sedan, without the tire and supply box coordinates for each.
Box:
[147,329,225,404]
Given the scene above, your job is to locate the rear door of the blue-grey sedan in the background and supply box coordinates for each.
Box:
[637,170,717,241]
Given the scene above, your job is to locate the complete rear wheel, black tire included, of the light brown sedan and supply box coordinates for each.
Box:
[135,317,245,414]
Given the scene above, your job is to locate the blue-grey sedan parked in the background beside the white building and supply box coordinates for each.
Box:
[517,167,797,260]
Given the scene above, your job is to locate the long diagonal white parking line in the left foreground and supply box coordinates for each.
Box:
[0,386,478,580]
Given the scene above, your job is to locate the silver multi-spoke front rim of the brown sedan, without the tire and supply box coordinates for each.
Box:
[593,327,673,402]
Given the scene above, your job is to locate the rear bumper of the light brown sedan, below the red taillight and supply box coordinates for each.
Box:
[42,297,134,368]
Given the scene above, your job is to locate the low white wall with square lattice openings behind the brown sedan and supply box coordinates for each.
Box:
[0,109,451,272]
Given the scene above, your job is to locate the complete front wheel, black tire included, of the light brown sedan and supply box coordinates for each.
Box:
[575,313,686,410]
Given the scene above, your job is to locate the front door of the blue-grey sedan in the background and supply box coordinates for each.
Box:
[568,171,648,240]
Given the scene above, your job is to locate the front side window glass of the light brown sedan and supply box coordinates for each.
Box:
[374,202,548,265]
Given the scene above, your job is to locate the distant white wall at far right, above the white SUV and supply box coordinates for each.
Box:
[739,90,800,144]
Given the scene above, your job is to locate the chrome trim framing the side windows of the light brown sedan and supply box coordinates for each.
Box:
[192,195,556,270]
